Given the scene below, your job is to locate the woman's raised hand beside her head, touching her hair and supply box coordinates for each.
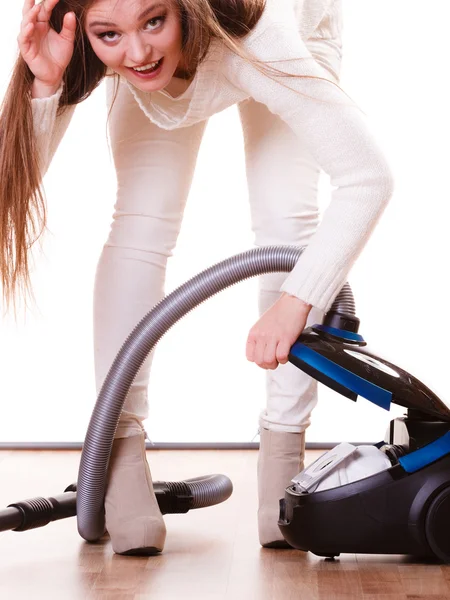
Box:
[17,0,76,95]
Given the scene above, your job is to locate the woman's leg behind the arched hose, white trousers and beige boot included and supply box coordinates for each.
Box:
[94,77,204,554]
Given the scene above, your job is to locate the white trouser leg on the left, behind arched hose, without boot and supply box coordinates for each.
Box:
[94,78,205,438]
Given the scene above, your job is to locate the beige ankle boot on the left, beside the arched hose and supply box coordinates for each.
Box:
[105,433,166,555]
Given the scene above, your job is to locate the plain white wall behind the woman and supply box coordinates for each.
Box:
[0,0,450,442]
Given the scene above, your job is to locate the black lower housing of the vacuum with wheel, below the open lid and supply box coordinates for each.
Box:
[279,424,450,562]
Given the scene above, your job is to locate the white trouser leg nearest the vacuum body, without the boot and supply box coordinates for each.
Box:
[240,100,322,433]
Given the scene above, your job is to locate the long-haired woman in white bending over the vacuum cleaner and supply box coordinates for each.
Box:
[0,0,392,554]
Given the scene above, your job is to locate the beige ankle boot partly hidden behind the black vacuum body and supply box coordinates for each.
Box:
[258,427,305,548]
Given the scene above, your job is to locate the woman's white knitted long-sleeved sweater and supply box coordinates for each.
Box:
[32,0,393,311]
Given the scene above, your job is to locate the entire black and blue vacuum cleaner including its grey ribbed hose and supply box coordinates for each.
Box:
[0,246,450,562]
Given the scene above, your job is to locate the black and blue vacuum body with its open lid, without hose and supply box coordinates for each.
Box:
[284,321,450,562]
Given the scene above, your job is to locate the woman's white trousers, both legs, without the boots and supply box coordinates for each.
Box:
[94,7,340,437]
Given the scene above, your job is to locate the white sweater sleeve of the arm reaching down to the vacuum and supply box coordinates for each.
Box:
[224,19,393,311]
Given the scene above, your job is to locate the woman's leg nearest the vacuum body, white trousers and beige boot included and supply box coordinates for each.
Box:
[240,0,341,547]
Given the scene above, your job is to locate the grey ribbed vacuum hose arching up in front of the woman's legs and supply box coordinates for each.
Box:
[77,246,354,541]
